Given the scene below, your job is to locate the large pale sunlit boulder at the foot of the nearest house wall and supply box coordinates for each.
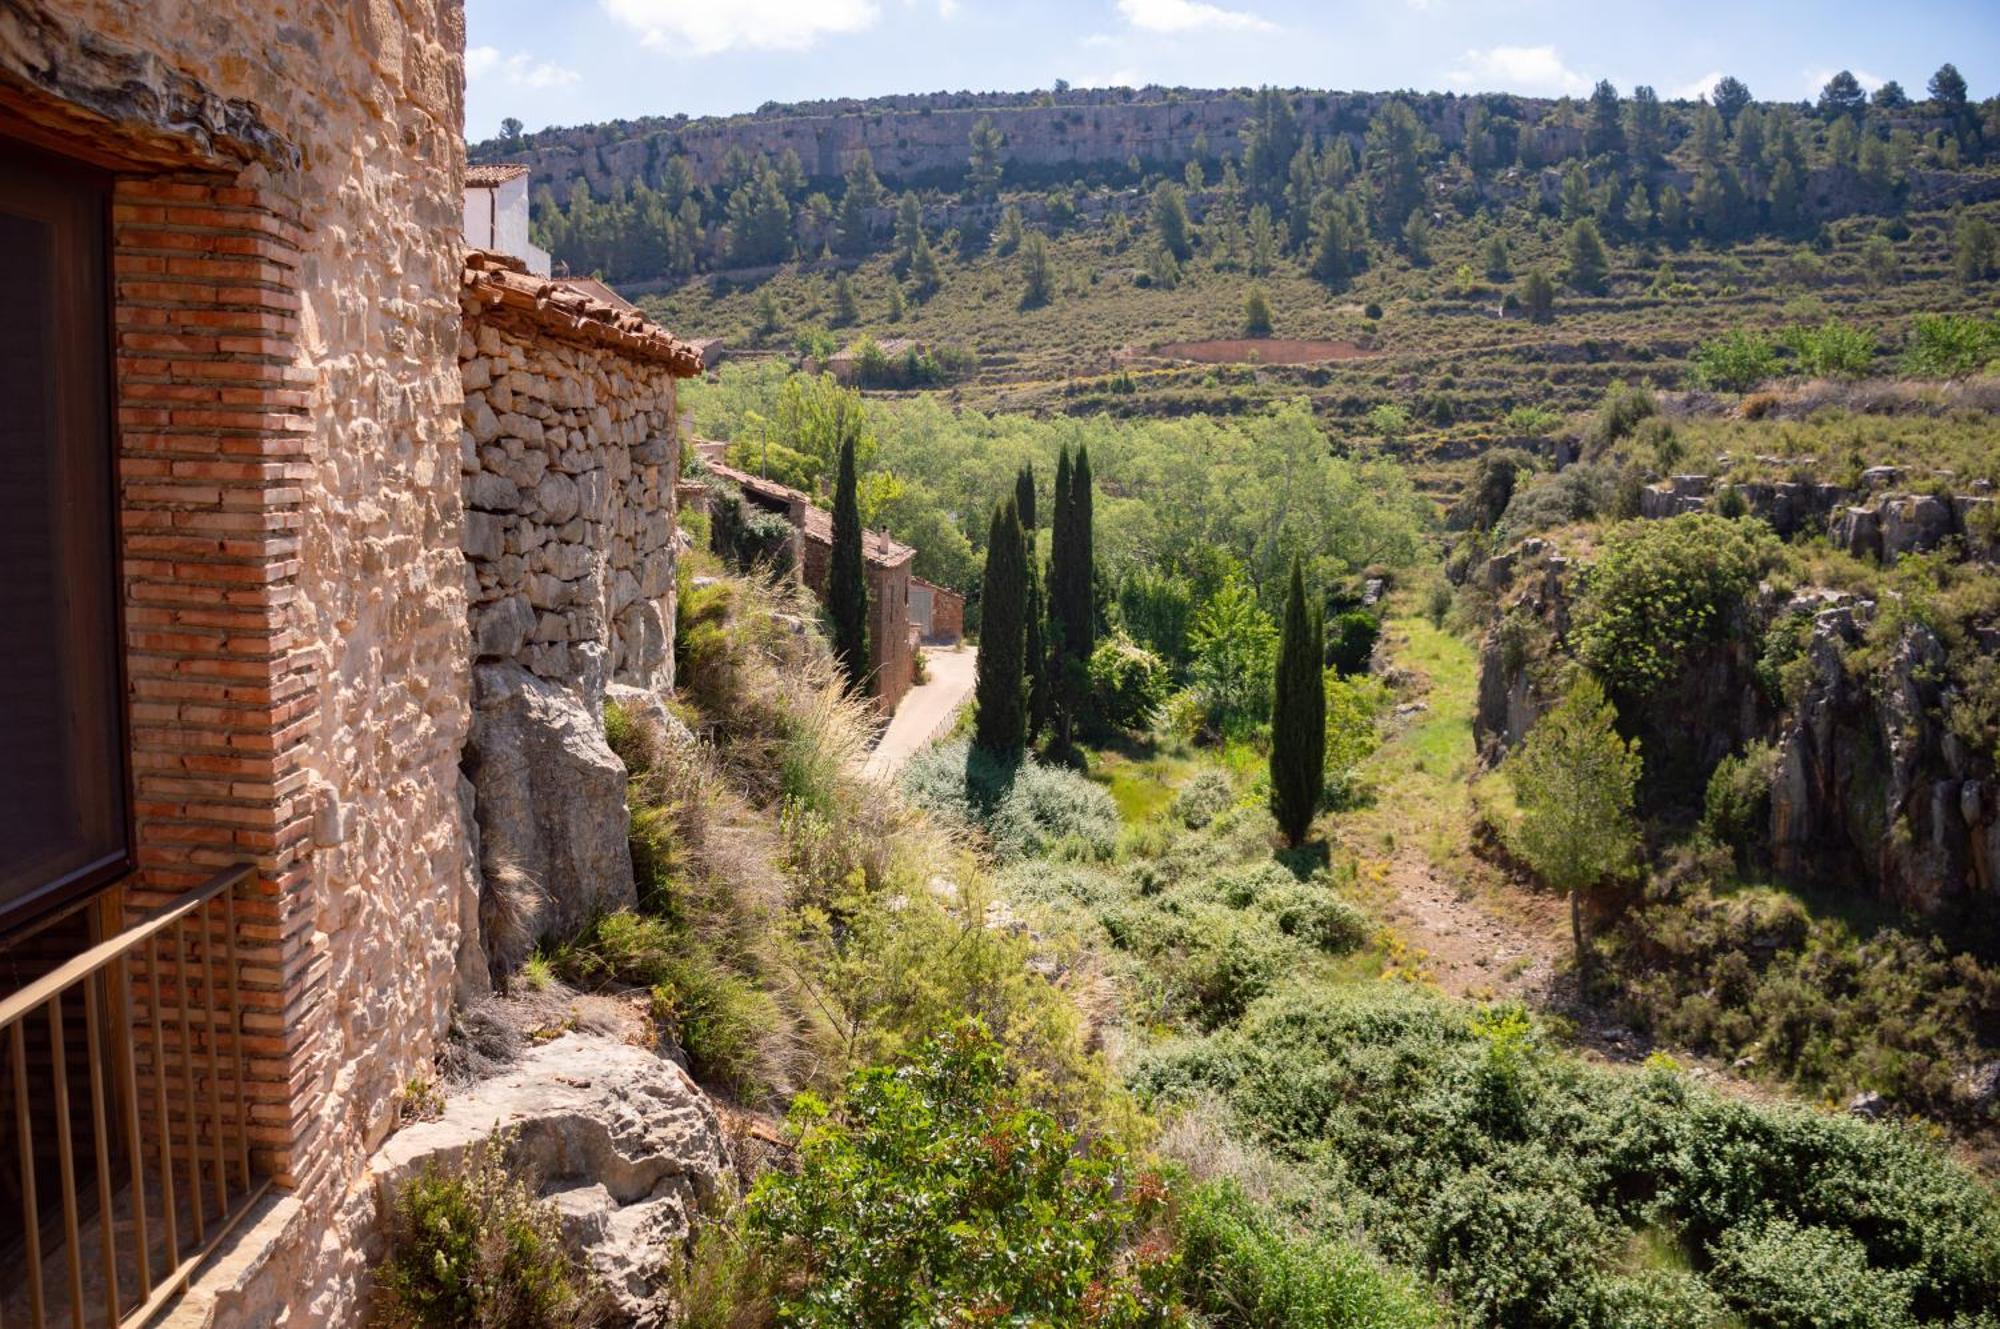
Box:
[370,1033,734,1325]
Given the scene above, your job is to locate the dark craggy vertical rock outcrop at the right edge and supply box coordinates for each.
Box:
[1770,604,2000,913]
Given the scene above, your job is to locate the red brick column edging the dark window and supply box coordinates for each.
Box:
[112,176,326,1183]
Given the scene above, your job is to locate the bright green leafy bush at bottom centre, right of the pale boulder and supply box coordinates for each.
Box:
[744,1023,1176,1329]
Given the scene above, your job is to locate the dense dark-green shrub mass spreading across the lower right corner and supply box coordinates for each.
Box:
[1134,985,2000,1329]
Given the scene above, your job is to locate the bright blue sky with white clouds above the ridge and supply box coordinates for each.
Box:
[466,0,2000,140]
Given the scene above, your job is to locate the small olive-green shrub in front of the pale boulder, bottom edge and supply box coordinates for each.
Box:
[376,1135,608,1329]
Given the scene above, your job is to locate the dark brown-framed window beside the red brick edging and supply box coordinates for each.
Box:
[0,140,130,927]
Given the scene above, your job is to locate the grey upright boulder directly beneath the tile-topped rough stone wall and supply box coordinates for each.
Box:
[466,662,638,944]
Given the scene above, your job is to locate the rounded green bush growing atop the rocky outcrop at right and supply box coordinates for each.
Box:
[1576,512,1780,699]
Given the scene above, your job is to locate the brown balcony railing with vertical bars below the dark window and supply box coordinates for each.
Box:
[0,867,268,1329]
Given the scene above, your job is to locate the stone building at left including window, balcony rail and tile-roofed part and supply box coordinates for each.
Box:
[0,0,698,1325]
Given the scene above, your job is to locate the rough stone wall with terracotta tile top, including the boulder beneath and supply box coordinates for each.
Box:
[458,252,700,956]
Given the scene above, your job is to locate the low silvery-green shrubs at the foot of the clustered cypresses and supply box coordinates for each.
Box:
[902,743,1118,861]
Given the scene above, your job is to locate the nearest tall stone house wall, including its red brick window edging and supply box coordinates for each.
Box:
[0,0,468,1325]
